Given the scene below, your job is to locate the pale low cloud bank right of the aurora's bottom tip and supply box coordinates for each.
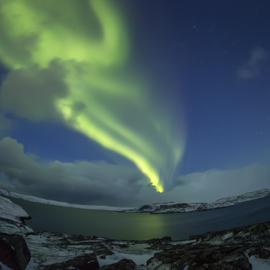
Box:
[169,164,270,201]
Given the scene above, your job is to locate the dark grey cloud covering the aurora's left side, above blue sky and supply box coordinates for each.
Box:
[0,62,66,121]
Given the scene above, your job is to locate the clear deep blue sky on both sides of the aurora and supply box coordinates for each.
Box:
[2,0,270,174]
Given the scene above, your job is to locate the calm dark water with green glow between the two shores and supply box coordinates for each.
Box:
[13,196,270,240]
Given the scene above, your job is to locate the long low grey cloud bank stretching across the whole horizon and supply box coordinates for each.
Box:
[0,137,270,206]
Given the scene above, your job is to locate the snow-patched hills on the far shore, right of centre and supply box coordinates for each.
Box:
[131,188,270,213]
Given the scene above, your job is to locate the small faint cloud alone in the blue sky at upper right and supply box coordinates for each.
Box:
[237,47,269,80]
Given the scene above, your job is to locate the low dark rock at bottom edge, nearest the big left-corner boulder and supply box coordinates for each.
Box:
[43,253,99,270]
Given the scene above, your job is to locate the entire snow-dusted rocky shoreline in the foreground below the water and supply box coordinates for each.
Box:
[0,195,270,270]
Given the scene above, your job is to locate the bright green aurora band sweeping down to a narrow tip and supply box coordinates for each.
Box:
[0,0,184,192]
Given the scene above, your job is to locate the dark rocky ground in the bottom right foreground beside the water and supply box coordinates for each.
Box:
[147,223,270,270]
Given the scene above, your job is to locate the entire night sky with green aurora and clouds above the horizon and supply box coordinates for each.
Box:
[0,0,270,207]
